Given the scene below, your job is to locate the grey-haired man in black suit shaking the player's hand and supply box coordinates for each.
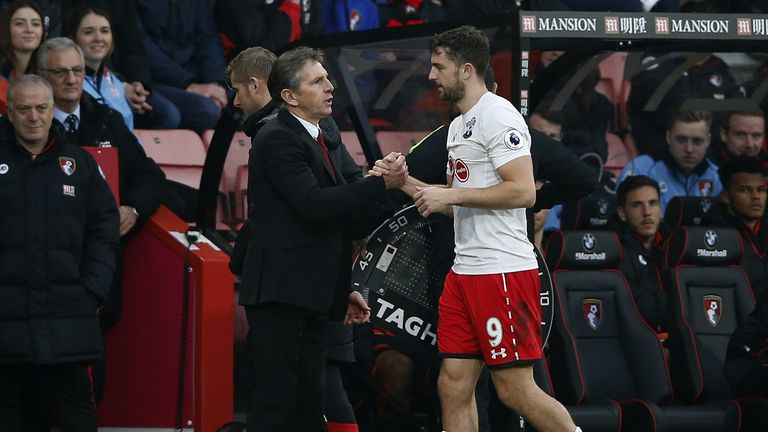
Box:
[240,48,407,432]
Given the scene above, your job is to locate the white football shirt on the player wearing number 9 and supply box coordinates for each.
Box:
[447,92,538,275]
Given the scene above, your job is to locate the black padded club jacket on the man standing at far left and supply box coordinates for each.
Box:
[0,118,119,364]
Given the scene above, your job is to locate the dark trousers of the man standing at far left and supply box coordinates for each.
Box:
[0,362,97,432]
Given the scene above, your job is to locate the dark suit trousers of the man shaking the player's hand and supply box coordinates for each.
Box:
[245,304,327,432]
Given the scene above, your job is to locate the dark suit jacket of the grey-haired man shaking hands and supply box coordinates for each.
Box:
[240,110,385,319]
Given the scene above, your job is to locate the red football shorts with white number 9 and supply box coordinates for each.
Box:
[437,269,542,368]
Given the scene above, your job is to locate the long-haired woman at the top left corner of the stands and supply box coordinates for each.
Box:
[0,0,45,115]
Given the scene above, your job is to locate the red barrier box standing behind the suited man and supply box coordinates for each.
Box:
[99,207,234,432]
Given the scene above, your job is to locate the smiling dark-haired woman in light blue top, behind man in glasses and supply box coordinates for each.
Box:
[68,7,133,130]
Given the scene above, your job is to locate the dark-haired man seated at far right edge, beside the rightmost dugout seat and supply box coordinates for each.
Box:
[705,156,768,293]
